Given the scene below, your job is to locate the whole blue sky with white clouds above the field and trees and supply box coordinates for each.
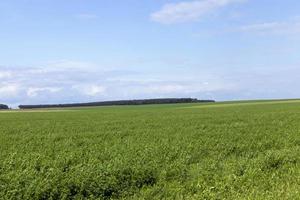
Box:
[0,0,300,107]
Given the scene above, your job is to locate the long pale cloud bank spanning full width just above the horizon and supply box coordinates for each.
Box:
[0,61,300,107]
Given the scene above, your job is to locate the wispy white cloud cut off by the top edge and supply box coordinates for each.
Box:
[151,0,245,24]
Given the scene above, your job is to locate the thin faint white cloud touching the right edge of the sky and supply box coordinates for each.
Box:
[237,19,300,35]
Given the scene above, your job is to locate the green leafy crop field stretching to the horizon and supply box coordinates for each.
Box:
[0,100,300,200]
